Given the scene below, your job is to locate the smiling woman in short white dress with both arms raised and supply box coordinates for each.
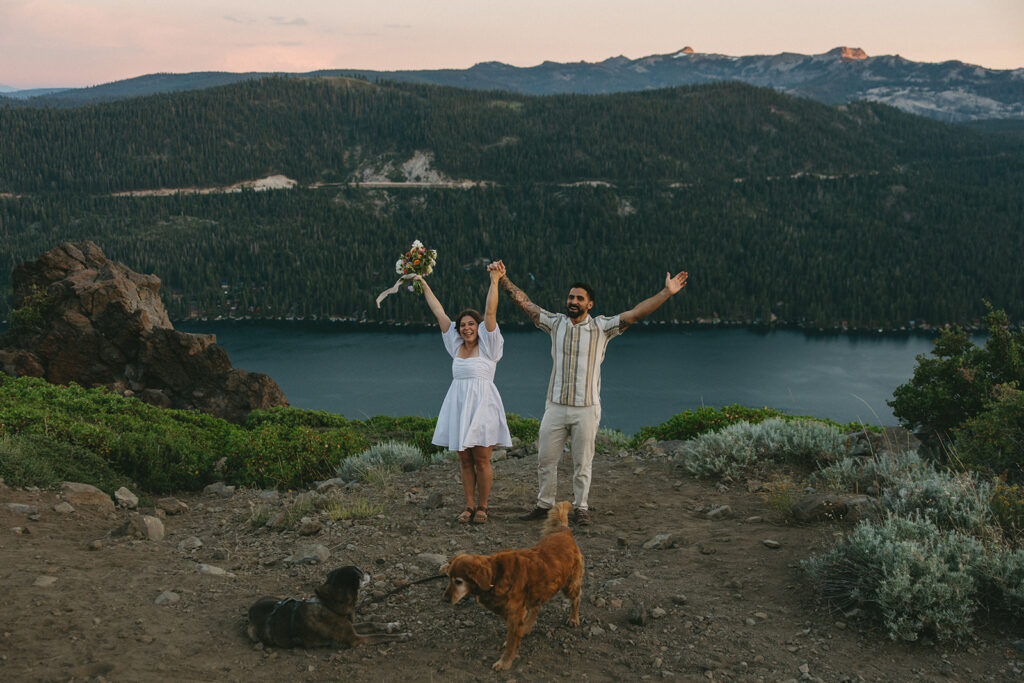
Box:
[416,269,512,524]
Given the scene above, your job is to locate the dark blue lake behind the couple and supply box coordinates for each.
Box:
[175,322,950,434]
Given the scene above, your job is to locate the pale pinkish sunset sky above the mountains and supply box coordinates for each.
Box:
[0,0,1024,88]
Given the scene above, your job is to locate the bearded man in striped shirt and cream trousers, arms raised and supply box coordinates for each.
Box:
[487,261,687,524]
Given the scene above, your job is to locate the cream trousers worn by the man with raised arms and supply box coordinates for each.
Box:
[537,400,601,510]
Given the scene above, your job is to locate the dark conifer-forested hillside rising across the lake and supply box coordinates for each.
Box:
[0,79,1024,329]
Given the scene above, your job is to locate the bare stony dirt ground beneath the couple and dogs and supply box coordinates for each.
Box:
[0,440,1024,682]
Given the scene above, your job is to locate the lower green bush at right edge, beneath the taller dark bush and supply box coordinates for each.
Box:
[953,385,1024,482]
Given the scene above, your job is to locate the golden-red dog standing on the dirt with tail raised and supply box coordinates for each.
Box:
[444,502,583,671]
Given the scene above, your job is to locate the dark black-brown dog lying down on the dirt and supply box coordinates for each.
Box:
[249,566,411,647]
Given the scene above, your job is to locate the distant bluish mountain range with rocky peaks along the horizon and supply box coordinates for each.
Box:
[0,47,1024,122]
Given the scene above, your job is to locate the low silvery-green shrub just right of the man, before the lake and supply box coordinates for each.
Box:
[676,418,845,477]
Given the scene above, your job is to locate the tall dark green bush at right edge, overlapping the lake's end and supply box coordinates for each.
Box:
[889,307,1024,447]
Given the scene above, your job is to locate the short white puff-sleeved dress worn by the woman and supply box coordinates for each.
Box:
[431,323,512,451]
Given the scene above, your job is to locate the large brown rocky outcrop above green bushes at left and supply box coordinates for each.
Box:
[0,242,288,422]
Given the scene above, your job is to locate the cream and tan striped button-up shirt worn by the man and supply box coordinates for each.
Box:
[537,308,625,405]
